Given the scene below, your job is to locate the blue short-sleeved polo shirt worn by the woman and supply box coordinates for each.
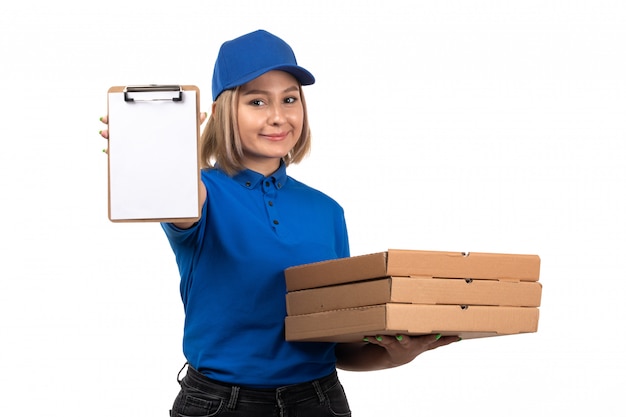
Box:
[162,164,349,388]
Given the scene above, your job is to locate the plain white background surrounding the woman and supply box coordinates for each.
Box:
[0,0,626,416]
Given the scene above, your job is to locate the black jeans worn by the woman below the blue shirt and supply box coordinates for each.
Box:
[170,366,351,417]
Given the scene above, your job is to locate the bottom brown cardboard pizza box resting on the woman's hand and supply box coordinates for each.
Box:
[285,303,539,342]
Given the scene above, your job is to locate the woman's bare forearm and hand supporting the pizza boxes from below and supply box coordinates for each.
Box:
[335,334,461,371]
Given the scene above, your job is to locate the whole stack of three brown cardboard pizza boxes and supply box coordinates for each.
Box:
[285,249,541,342]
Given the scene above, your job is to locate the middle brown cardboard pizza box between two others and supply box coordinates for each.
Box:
[287,277,541,315]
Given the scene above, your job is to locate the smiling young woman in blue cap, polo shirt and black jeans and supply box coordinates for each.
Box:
[101,30,458,417]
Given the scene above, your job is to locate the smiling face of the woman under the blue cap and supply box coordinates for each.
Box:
[237,71,304,175]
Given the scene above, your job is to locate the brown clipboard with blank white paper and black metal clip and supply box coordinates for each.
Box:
[108,84,201,222]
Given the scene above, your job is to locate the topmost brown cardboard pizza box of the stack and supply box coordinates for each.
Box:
[285,249,540,291]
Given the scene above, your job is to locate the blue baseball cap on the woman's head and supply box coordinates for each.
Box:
[213,30,315,101]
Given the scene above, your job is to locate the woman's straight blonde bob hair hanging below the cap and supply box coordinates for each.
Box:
[200,86,311,176]
